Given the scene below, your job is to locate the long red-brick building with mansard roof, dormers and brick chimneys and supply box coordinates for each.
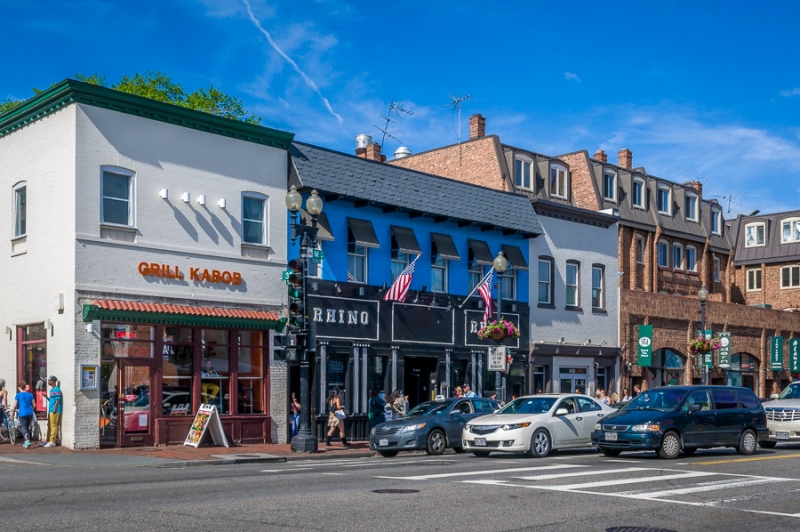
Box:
[390,115,800,396]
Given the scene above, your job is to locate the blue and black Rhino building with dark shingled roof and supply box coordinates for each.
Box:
[288,143,542,439]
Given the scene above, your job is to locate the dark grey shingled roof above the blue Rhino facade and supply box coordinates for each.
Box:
[289,142,543,237]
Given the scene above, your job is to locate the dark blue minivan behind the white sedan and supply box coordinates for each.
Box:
[592,386,769,459]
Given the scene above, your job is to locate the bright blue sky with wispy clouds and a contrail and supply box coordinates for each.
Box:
[6,0,800,217]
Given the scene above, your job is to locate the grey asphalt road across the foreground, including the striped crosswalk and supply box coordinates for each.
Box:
[0,446,800,532]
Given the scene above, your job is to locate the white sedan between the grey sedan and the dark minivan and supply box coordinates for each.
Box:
[461,394,616,458]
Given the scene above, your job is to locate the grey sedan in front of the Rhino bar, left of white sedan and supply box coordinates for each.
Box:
[369,397,500,457]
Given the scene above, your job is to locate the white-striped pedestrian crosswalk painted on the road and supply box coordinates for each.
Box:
[378,460,800,518]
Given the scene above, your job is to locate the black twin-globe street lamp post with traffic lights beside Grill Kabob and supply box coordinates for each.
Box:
[286,185,322,453]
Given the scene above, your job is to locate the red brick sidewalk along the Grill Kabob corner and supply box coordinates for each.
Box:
[0,441,375,467]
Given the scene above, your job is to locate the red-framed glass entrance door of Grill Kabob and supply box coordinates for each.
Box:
[117,359,155,447]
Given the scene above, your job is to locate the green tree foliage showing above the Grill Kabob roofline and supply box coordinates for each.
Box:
[0,70,261,124]
